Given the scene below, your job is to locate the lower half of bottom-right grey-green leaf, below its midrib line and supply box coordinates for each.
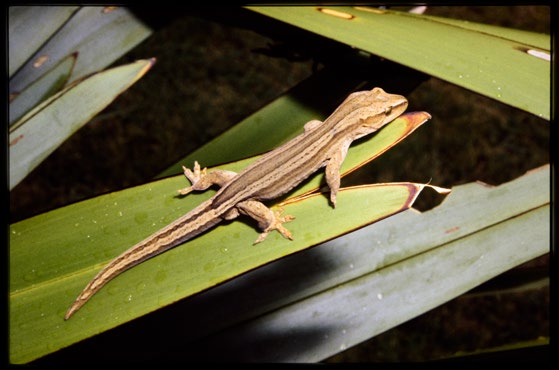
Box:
[194,205,550,362]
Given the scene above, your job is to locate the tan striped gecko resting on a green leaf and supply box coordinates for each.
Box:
[64,87,408,320]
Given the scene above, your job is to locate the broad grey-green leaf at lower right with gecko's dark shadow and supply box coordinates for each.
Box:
[155,166,550,362]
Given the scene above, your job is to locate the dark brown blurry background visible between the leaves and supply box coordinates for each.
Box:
[10,6,550,362]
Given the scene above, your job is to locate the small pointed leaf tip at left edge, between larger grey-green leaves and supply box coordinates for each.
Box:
[9,54,77,125]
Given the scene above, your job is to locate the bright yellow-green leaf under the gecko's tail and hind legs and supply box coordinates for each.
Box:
[10,178,423,363]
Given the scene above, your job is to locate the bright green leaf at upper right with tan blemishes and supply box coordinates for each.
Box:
[248,6,551,119]
